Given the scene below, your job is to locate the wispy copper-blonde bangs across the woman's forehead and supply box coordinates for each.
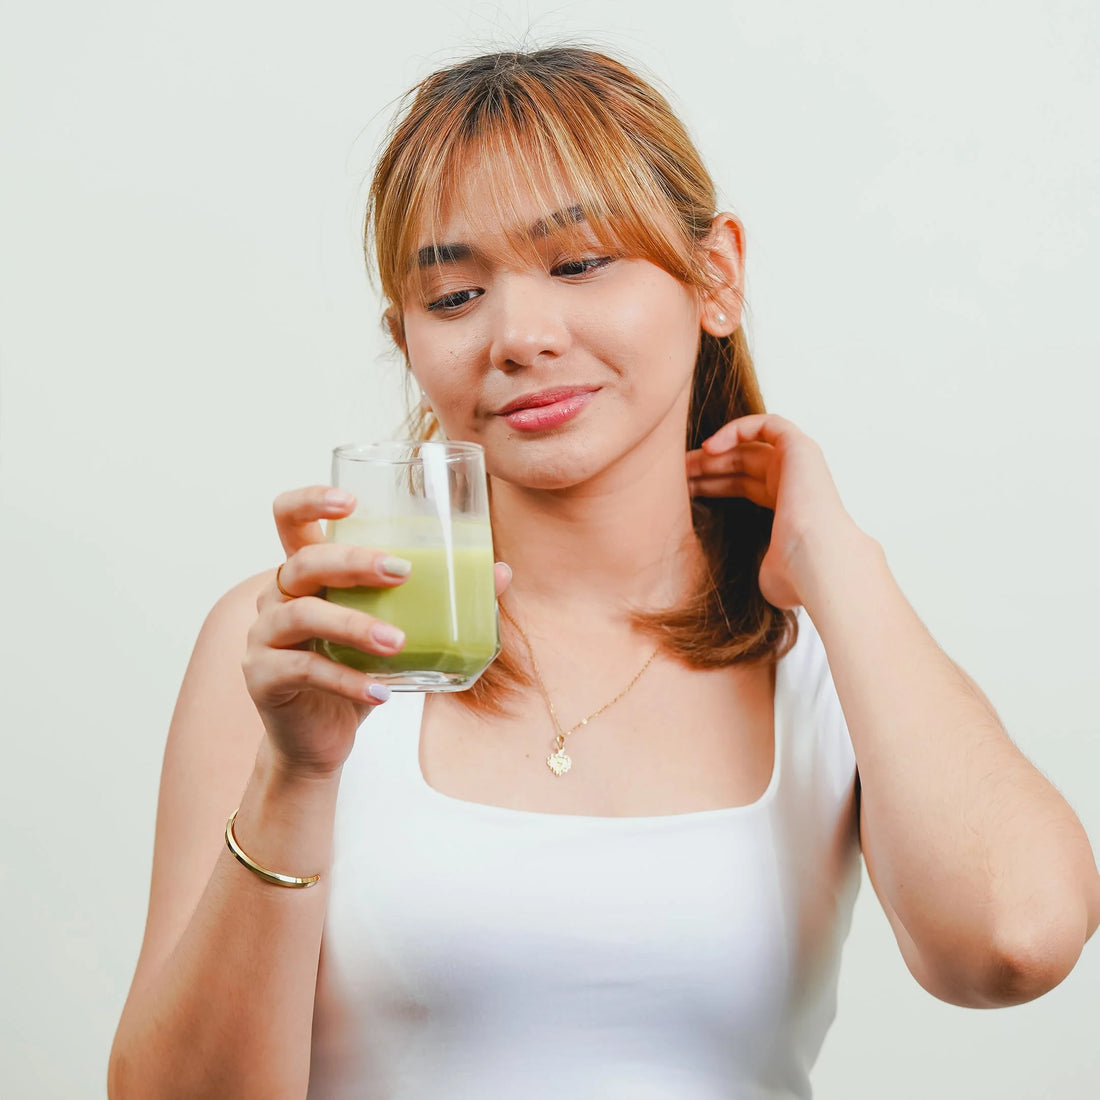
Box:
[375,67,713,321]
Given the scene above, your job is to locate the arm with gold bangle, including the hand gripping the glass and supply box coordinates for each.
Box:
[108,486,420,1100]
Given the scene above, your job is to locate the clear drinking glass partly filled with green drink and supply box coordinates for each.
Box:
[316,441,501,691]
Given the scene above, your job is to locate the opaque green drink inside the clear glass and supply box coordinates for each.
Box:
[317,519,499,686]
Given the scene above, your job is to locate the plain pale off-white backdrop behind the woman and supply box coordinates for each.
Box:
[0,0,1100,1100]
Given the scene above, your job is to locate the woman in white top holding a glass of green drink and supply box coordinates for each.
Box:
[110,48,1100,1100]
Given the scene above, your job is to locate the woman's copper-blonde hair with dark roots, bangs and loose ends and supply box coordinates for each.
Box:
[366,46,796,710]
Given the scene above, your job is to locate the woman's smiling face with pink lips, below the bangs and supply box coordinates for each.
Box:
[404,160,703,490]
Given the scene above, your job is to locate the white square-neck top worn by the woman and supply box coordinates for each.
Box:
[309,612,859,1100]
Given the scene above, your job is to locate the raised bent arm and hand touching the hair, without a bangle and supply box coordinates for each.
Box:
[688,415,1100,1007]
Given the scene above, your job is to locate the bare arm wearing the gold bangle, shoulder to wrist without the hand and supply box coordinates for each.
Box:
[109,579,339,1100]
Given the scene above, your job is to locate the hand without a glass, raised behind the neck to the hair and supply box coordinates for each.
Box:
[688,413,867,608]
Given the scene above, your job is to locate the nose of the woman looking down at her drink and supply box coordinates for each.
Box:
[487,276,570,371]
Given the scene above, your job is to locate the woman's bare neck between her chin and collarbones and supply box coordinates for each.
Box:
[493,442,703,622]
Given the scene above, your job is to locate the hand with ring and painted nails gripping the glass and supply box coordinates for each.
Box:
[243,485,405,777]
